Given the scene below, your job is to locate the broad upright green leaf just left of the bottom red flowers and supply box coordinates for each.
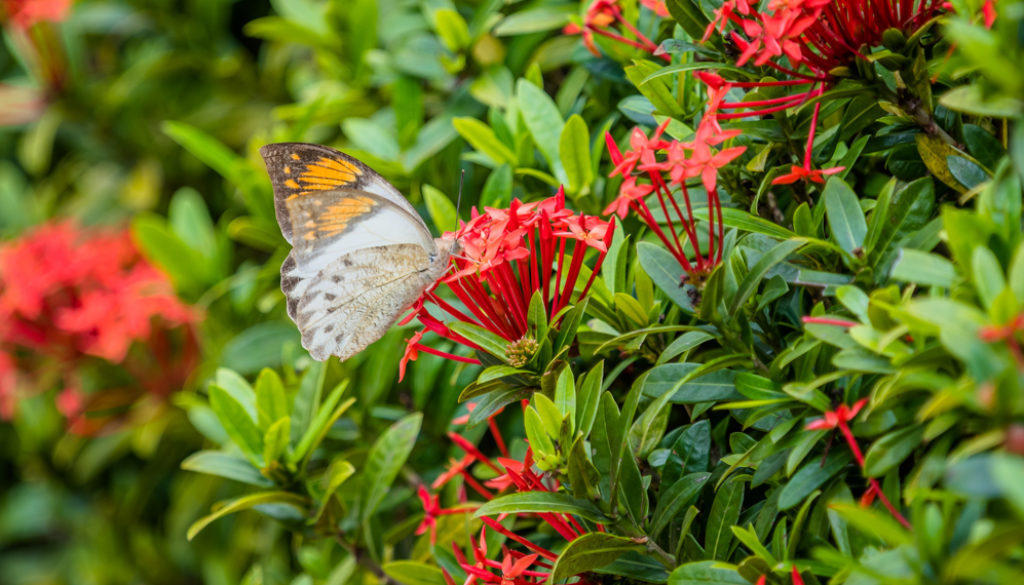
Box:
[360,413,423,523]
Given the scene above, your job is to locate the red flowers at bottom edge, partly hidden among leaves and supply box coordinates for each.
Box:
[417,401,604,585]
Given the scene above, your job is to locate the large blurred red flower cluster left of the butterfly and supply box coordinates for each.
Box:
[0,222,198,433]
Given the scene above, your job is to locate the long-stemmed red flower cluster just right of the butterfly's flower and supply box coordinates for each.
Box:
[604,115,746,282]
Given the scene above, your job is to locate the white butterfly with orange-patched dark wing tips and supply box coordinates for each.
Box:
[260,142,458,361]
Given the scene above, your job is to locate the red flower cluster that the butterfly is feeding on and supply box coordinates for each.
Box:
[400,189,614,376]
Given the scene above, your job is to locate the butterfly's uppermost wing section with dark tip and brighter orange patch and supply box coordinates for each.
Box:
[260,142,426,243]
